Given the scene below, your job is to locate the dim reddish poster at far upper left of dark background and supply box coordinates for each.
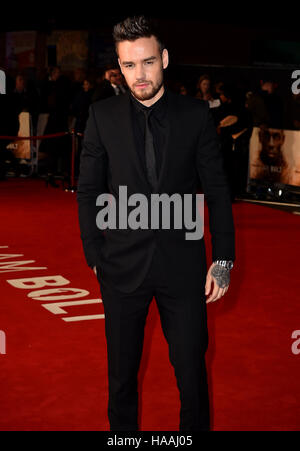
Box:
[6,31,37,69]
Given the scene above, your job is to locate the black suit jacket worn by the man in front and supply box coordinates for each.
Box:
[77,91,235,293]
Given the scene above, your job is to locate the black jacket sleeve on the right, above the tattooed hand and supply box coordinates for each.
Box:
[197,102,235,261]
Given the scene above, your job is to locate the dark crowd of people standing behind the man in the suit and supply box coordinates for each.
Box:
[0,64,300,201]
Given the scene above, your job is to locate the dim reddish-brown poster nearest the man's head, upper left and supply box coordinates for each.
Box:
[47,30,88,70]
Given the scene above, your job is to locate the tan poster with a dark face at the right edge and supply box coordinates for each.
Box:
[249,127,300,187]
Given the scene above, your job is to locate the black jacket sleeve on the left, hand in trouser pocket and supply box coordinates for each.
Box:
[77,105,108,268]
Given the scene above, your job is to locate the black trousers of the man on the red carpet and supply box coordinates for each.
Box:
[97,244,210,431]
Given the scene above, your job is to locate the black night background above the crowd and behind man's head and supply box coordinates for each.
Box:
[0,0,300,131]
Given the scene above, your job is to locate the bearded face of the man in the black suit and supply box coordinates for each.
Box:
[118,36,169,101]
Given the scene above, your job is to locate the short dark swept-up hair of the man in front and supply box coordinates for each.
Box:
[113,16,165,53]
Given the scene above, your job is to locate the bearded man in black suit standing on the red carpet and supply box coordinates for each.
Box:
[77,16,235,431]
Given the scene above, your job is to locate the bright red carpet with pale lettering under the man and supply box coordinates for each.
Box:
[0,179,300,431]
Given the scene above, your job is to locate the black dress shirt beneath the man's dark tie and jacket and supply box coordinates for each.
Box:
[130,91,168,177]
